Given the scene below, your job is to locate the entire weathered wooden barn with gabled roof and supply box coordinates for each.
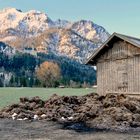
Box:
[86,33,140,95]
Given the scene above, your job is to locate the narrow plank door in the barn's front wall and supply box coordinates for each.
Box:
[117,59,128,92]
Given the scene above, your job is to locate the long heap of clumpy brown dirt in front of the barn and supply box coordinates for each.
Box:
[0,93,140,129]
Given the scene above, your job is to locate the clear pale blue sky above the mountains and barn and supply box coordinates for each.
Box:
[0,0,140,38]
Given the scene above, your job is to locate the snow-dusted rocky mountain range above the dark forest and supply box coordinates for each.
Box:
[0,8,109,63]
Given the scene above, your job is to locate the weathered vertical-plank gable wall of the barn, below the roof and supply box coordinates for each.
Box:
[97,41,140,95]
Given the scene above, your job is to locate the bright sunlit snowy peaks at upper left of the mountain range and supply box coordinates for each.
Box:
[0,8,55,37]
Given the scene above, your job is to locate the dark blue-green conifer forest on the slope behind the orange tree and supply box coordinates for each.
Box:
[0,52,96,87]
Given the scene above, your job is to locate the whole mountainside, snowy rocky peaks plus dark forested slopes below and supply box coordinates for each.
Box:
[0,8,109,87]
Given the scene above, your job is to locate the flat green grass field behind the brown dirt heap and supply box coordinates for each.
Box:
[0,88,95,108]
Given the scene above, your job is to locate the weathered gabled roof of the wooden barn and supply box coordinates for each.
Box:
[86,33,140,64]
